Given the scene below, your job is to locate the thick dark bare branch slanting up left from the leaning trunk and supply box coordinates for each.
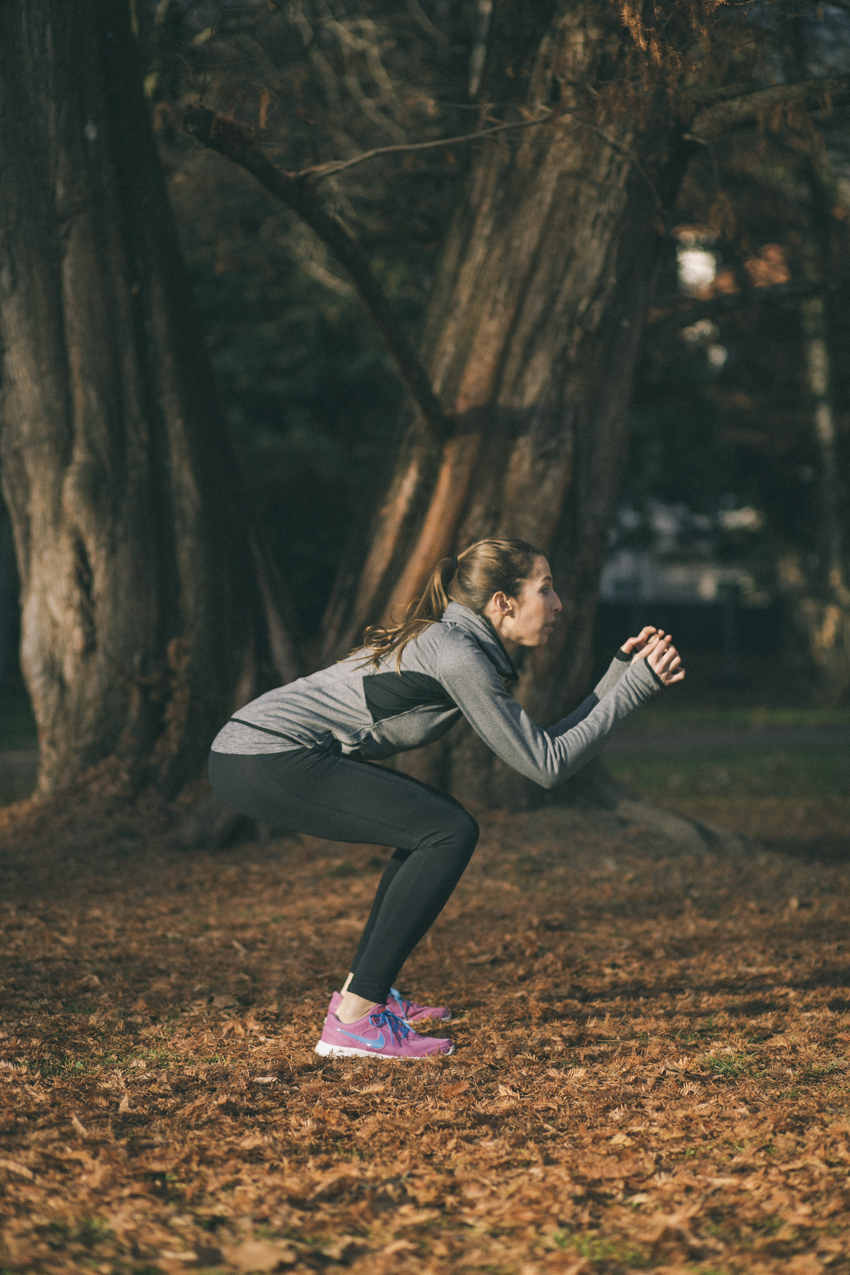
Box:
[184,106,452,442]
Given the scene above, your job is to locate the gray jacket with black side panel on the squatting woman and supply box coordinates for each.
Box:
[213,602,661,788]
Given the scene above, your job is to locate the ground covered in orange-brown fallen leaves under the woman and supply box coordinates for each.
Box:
[0,770,850,1275]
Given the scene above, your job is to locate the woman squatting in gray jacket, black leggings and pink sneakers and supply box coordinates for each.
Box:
[209,539,684,1058]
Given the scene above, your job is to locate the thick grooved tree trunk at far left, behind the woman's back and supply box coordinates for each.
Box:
[0,0,294,794]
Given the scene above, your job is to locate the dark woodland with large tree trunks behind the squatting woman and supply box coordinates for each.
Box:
[0,0,850,805]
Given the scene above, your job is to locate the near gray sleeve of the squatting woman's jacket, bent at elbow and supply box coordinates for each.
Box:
[437,635,661,788]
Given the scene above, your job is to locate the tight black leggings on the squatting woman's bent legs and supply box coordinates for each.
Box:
[209,748,478,1005]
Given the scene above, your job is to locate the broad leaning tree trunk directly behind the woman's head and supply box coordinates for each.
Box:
[318,0,683,803]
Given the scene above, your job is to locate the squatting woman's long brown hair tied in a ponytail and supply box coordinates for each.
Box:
[357,539,540,668]
